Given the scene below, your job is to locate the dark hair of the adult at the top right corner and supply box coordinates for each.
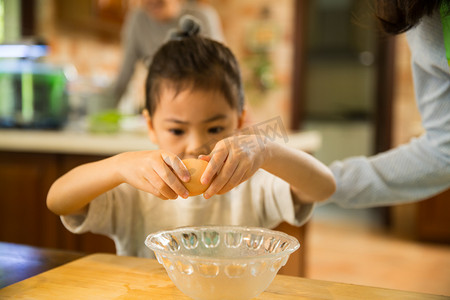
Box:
[375,0,450,34]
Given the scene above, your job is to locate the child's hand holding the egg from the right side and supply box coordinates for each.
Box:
[200,135,269,199]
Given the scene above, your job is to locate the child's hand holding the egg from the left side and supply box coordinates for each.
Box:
[117,150,190,200]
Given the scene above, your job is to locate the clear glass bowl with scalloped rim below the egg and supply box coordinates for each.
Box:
[145,226,300,300]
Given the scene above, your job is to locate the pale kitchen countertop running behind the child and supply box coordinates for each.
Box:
[0,129,321,155]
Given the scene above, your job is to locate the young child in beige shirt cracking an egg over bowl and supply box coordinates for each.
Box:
[47,18,335,257]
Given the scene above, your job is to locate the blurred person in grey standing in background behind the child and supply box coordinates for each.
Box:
[109,0,224,105]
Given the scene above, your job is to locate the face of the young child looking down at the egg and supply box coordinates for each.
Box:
[145,88,244,159]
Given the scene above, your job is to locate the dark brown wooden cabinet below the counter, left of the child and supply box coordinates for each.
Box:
[0,152,115,253]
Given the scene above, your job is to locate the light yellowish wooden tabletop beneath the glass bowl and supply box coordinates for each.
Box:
[0,254,446,300]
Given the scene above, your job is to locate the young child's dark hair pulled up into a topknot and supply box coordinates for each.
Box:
[145,17,244,116]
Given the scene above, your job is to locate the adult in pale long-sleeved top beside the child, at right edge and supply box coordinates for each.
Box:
[327,0,450,208]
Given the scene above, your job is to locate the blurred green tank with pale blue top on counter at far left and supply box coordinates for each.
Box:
[0,45,69,129]
